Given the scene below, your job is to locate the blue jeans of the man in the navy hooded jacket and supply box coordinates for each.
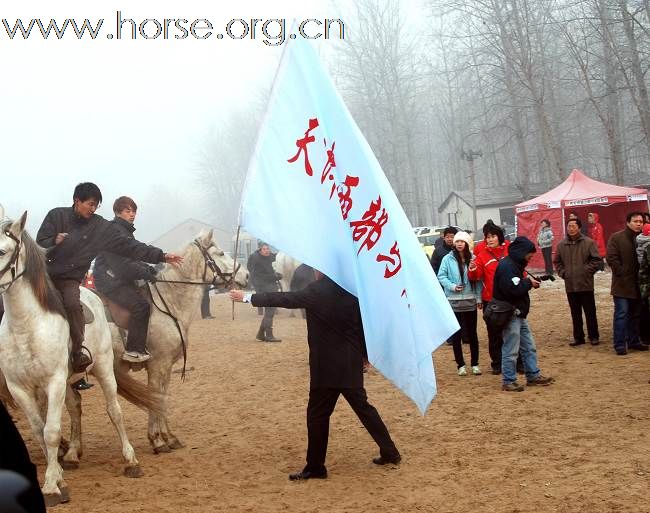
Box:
[501,317,539,385]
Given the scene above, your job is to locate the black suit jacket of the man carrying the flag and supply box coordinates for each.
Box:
[251,277,365,388]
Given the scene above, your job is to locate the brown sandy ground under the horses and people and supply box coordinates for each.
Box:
[10,274,650,513]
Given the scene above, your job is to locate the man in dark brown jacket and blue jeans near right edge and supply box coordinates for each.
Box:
[607,212,648,356]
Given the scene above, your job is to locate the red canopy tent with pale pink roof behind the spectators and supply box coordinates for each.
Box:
[515,169,648,269]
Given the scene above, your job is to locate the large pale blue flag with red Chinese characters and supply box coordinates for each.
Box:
[240,40,458,413]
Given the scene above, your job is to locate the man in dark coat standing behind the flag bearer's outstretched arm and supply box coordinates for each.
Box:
[246,242,282,342]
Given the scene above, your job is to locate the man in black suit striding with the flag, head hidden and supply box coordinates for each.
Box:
[230,271,401,481]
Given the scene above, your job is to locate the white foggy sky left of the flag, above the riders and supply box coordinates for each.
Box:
[0,0,337,241]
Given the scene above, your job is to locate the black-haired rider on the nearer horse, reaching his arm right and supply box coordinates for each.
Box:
[36,182,183,372]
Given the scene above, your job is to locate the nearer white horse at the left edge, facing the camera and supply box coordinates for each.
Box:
[0,212,162,506]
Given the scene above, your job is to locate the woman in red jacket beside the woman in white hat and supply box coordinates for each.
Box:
[469,223,510,374]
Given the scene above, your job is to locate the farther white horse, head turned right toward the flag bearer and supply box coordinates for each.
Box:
[112,230,248,454]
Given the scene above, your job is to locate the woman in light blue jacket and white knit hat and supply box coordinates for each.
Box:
[438,232,481,376]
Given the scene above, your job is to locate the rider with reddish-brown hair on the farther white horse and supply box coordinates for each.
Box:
[93,196,156,363]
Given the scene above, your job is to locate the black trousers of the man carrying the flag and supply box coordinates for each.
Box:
[304,387,399,473]
